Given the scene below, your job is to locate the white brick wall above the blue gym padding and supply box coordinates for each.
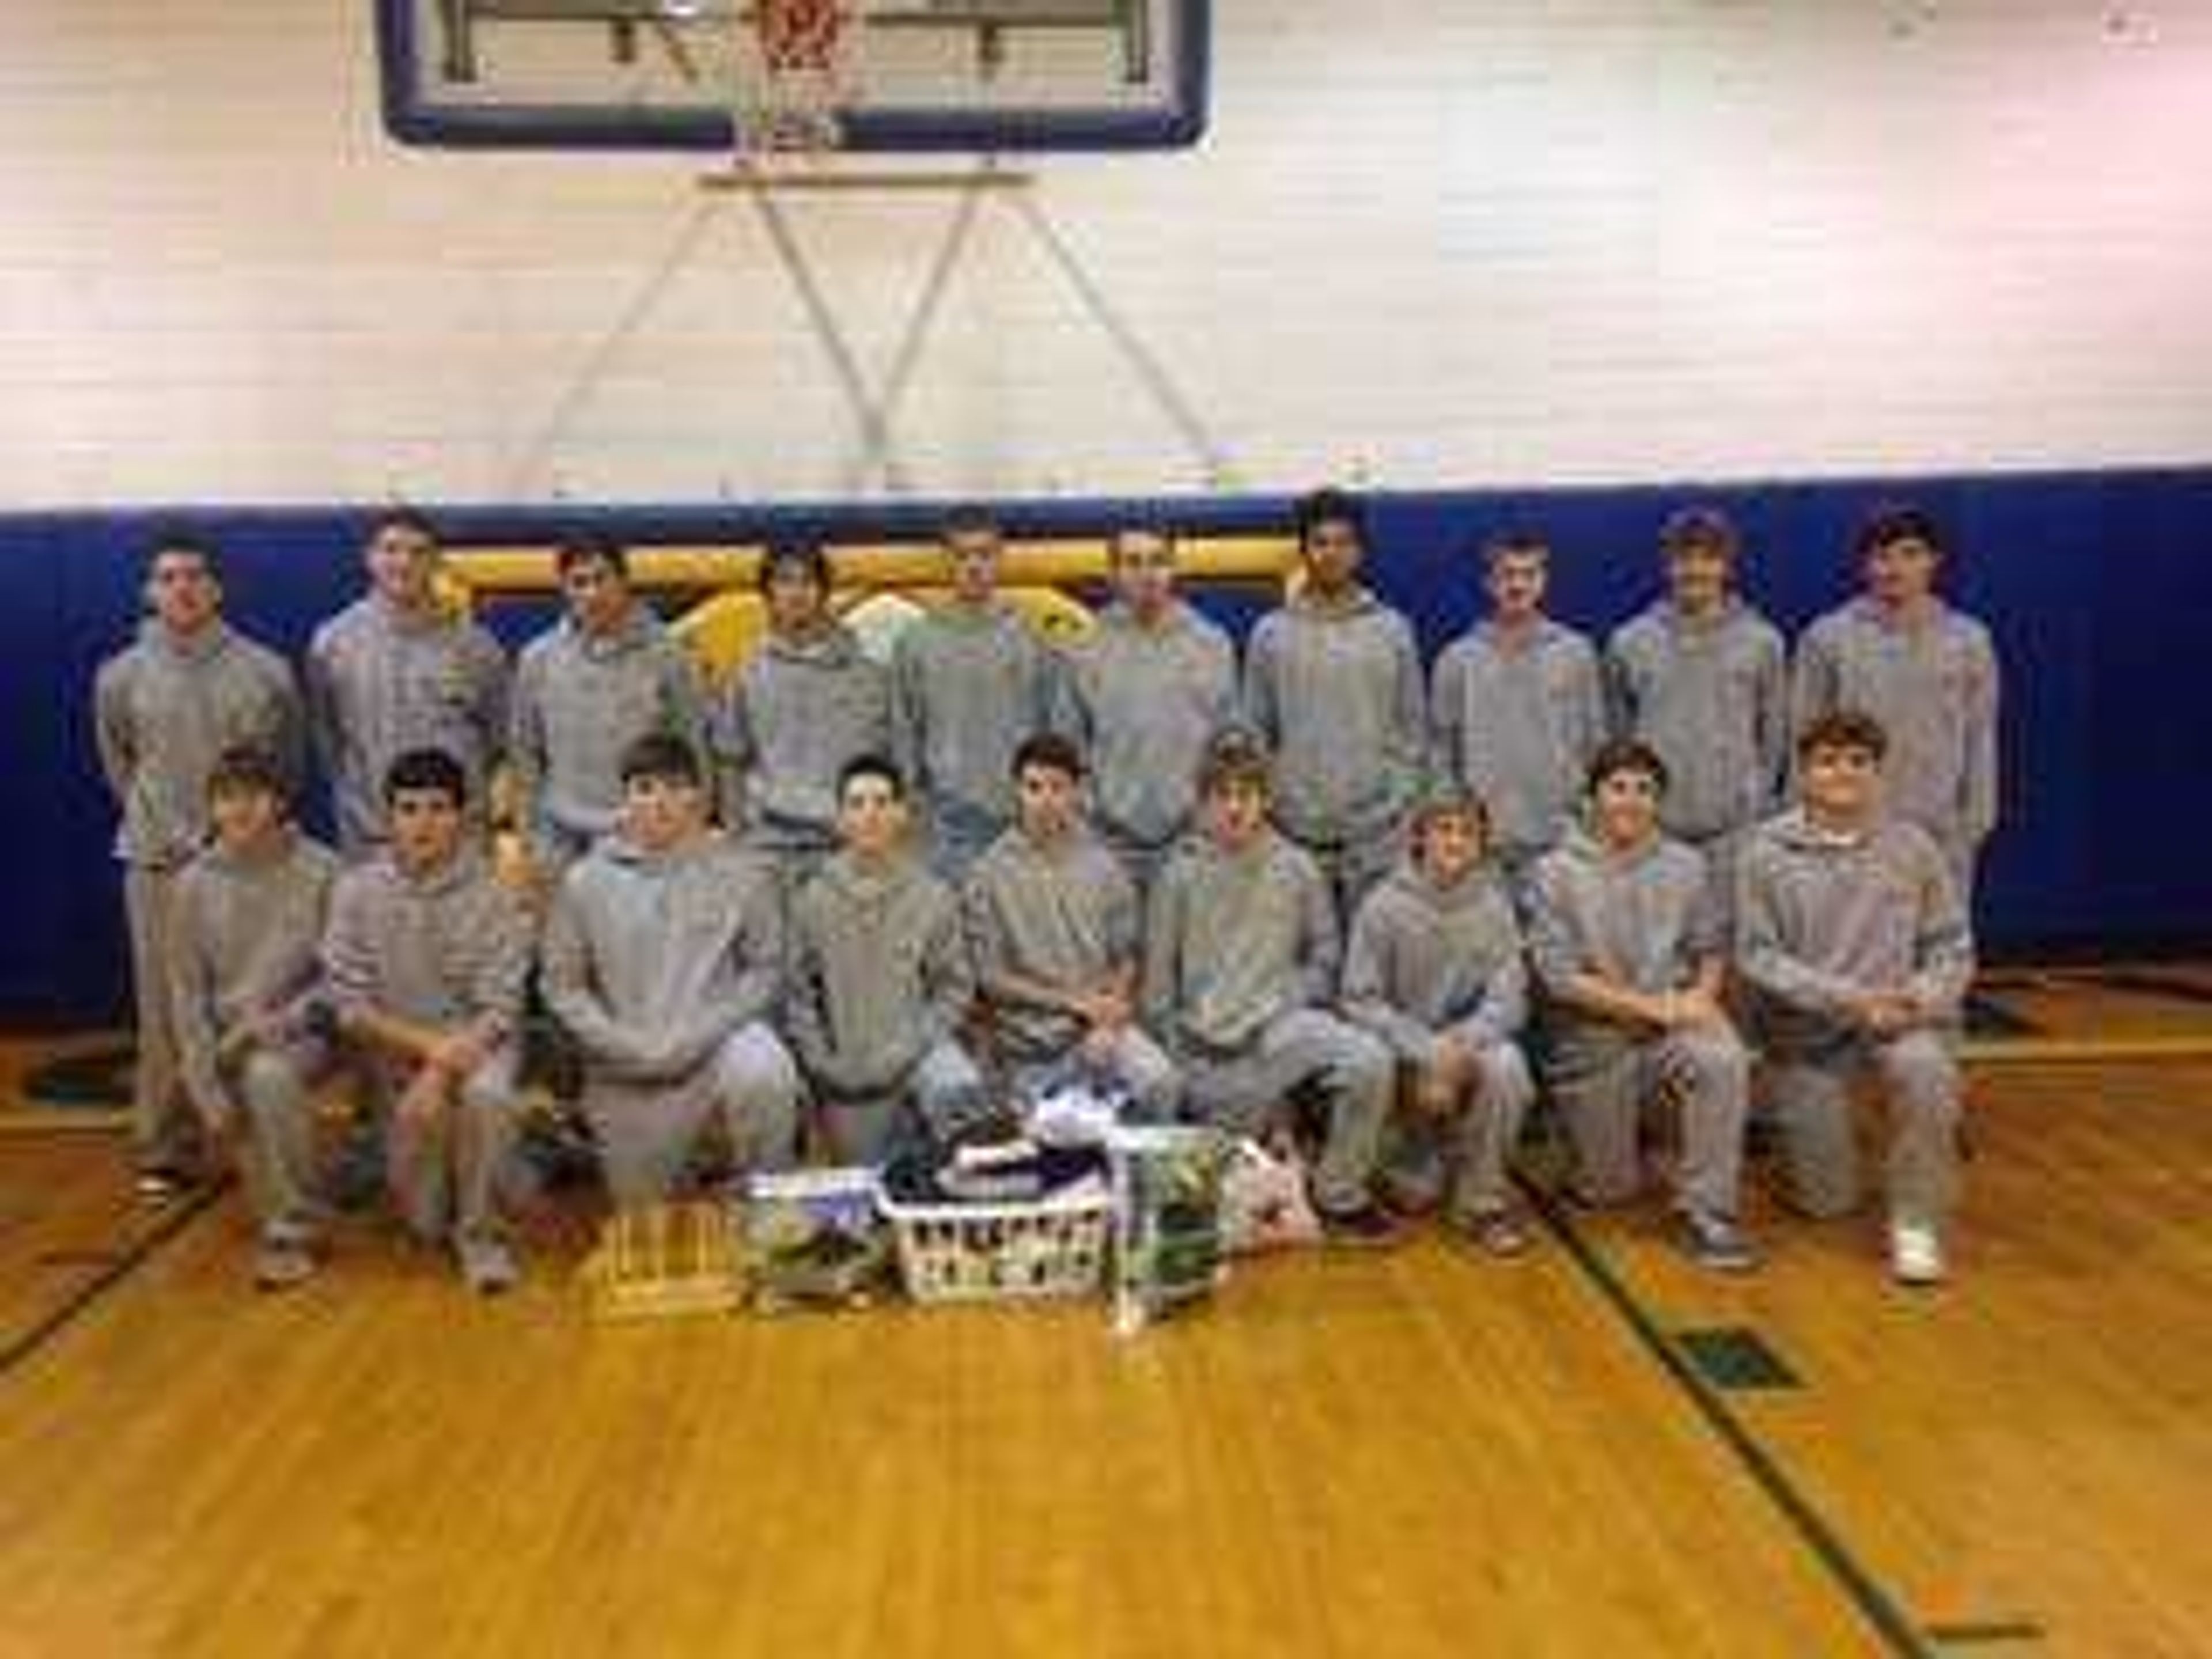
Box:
[0,0,2212,506]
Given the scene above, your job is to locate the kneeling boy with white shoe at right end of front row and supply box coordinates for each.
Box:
[1736,710,1973,1285]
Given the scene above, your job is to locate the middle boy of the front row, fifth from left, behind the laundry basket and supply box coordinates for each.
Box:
[962,732,1175,1124]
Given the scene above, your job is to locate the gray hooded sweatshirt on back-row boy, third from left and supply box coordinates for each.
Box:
[506,606,708,843]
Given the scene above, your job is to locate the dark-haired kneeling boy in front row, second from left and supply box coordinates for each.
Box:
[323,750,529,1294]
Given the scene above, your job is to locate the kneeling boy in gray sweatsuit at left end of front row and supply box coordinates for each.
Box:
[168,748,339,1290]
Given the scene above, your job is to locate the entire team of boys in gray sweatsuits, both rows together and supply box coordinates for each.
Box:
[93,491,1999,1294]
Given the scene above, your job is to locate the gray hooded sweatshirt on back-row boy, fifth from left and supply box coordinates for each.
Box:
[892,604,1058,845]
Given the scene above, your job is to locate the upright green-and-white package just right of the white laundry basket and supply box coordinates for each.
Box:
[1108,1126,1228,1336]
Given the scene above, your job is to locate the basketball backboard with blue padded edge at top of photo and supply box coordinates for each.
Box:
[376,0,1210,153]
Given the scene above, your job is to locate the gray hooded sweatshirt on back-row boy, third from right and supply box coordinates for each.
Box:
[1429,617,1606,856]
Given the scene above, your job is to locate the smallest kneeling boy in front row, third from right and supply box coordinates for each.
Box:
[1343,783,1535,1256]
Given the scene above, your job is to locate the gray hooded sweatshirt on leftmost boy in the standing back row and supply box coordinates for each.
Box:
[93,619,305,869]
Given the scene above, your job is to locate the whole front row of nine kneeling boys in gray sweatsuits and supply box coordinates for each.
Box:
[171,712,1973,1292]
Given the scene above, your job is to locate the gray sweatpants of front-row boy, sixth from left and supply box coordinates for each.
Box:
[1183,1009,1396,1212]
